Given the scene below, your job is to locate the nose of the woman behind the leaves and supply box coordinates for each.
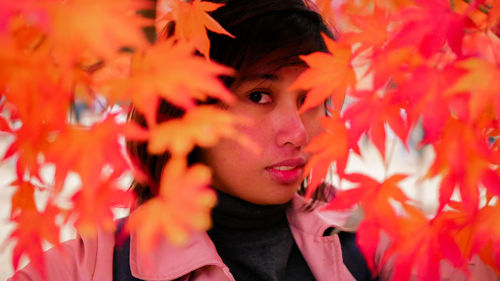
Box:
[276,103,308,148]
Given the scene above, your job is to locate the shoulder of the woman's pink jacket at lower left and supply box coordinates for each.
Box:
[10,228,115,281]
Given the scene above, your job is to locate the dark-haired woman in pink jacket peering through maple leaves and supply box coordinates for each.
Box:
[10,0,382,281]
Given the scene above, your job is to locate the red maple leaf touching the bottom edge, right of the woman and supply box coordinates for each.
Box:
[384,205,463,281]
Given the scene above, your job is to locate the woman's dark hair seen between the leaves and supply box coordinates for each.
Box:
[127,0,333,204]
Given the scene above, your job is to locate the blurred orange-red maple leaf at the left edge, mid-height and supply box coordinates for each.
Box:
[3,69,70,182]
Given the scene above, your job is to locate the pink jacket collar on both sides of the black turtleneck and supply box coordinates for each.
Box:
[130,195,354,280]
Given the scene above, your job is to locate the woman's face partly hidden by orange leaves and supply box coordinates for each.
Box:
[203,66,325,205]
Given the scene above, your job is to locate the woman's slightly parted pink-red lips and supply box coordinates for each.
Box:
[266,158,306,184]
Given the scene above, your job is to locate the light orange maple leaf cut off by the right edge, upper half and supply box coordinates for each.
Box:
[449,58,500,121]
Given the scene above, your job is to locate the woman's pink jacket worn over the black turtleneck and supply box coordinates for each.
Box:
[11,196,500,281]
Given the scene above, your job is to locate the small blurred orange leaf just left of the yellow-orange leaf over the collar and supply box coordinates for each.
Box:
[71,178,135,236]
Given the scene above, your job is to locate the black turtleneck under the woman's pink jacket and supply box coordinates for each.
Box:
[208,192,315,281]
